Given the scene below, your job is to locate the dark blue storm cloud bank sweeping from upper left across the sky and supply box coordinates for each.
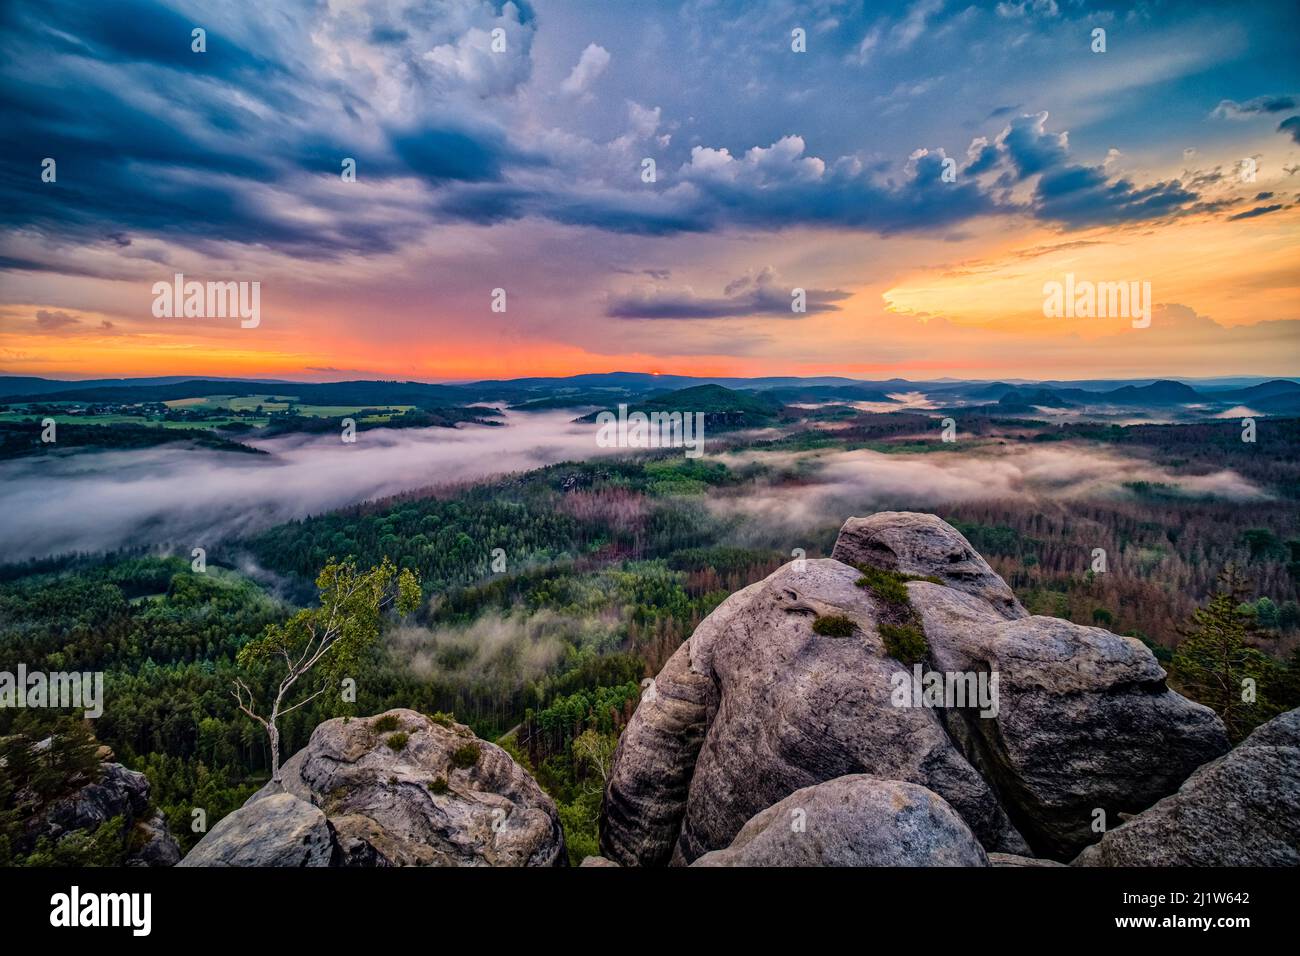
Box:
[0,0,1279,265]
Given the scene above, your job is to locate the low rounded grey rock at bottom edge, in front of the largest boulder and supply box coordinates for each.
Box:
[692,774,988,866]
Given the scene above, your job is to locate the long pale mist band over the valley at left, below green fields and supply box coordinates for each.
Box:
[0,411,616,563]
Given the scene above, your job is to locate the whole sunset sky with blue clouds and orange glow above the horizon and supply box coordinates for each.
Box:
[0,0,1300,381]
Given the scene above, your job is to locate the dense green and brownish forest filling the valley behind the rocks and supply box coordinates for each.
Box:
[0,415,1300,862]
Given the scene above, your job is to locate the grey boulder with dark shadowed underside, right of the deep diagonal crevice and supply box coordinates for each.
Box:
[907,581,1227,860]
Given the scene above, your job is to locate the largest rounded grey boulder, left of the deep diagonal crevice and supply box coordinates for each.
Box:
[601,559,1028,865]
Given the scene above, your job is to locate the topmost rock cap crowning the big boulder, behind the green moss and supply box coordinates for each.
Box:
[831,511,1028,619]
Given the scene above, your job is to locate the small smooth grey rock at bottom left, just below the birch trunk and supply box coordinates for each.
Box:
[181,793,334,866]
